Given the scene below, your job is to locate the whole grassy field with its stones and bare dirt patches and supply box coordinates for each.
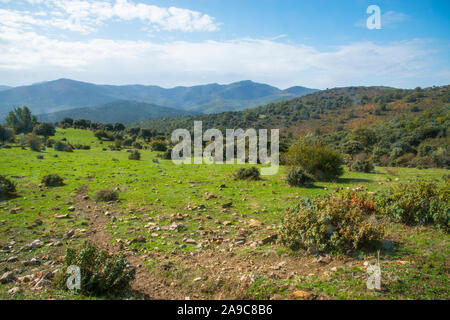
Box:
[0,129,450,299]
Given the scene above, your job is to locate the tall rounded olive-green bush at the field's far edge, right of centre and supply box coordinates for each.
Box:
[287,141,344,181]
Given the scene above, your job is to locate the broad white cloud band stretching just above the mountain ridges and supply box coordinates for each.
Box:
[0,22,440,88]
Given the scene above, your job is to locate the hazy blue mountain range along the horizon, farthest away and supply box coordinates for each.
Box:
[0,79,318,119]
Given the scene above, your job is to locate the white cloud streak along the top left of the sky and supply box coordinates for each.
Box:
[0,0,219,34]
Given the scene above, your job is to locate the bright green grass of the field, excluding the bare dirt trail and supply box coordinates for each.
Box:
[0,129,450,299]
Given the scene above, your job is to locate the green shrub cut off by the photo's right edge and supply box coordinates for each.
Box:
[377,180,450,232]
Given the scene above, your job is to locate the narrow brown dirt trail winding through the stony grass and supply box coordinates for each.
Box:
[75,187,185,300]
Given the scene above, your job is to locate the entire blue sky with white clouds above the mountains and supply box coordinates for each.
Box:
[0,0,450,89]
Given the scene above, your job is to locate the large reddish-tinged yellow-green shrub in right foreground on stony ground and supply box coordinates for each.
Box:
[280,193,384,253]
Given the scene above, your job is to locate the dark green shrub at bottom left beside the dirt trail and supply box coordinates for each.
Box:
[57,243,135,297]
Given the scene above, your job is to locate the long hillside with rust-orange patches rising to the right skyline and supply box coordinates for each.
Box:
[133,86,450,135]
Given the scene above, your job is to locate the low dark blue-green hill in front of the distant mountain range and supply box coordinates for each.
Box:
[38,100,198,124]
